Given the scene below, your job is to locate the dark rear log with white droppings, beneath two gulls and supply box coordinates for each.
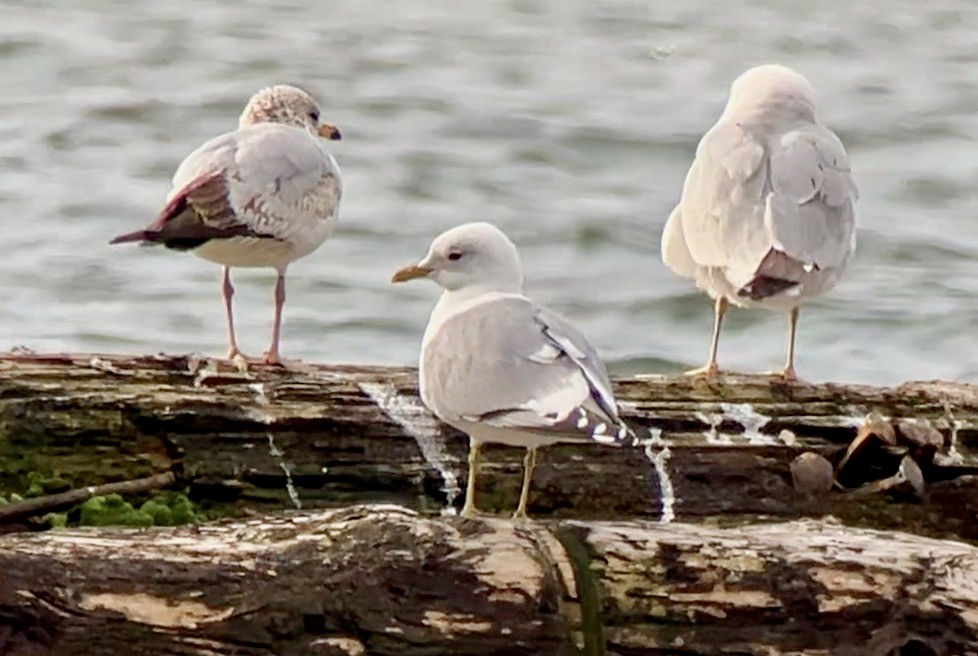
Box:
[0,353,978,540]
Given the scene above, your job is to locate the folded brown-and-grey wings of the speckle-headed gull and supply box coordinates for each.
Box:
[155,123,342,239]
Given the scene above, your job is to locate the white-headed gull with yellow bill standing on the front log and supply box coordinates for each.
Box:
[392,223,636,518]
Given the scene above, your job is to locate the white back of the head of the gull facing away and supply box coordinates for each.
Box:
[723,64,815,121]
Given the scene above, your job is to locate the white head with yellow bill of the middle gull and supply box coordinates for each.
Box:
[391,222,523,293]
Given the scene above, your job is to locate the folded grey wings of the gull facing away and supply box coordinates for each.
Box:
[664,121,858,292]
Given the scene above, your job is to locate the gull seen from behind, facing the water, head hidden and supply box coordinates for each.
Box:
[662,64,858,380]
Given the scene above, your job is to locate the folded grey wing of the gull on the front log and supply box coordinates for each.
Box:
[421,296,634,443]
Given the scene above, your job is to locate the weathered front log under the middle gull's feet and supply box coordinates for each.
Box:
[0,506,978,656]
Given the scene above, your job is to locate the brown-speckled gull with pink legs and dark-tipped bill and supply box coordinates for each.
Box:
[110,85,343,364]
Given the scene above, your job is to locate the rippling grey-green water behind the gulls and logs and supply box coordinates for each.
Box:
[0,0,978,383]
